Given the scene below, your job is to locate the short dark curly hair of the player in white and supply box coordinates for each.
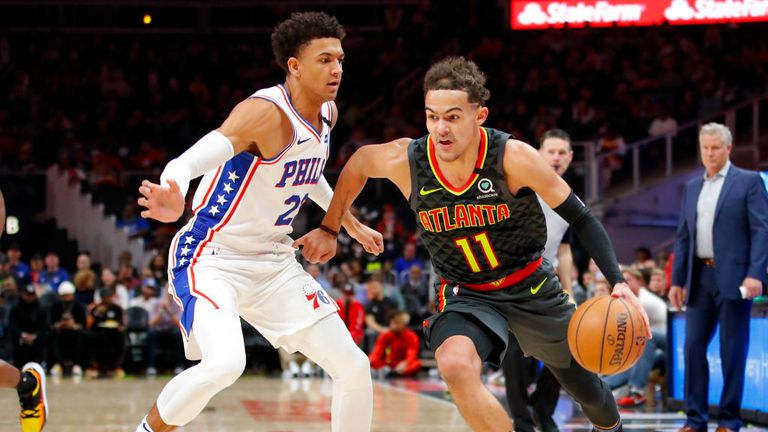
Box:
[272,12,346,73]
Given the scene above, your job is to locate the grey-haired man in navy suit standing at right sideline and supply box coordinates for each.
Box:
[669,123,768,432]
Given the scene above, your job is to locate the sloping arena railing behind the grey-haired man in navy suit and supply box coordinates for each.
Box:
[574,94,768,204]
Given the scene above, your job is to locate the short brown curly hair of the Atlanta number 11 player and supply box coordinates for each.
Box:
[424,57,491,105]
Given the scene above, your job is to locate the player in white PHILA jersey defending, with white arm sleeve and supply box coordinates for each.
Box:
[136,12,383,432]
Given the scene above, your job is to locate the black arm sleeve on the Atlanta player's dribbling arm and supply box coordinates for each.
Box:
[554,191,625,287]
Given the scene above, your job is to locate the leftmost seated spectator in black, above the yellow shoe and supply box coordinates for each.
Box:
[8,285,46,368]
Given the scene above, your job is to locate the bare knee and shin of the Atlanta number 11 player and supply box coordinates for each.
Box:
[435,336,512,432]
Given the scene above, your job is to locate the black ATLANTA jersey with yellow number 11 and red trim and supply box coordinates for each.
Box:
[408,128,547,284]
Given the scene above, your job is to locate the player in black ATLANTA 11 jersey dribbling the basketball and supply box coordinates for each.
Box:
[294,58,650,432]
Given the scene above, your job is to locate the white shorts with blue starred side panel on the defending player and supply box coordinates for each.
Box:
[168,238,338,360]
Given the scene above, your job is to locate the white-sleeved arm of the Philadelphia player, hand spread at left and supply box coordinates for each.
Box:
[138,99,280,222]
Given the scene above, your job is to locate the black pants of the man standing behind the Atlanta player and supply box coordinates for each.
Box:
[501,334,560,431]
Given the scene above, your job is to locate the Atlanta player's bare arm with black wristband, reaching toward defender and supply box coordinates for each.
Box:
[293,138,411,262]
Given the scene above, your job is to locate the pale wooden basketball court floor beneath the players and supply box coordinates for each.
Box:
[0,375,768,432]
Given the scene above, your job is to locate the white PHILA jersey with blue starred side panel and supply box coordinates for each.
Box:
[177,85,333,259]
